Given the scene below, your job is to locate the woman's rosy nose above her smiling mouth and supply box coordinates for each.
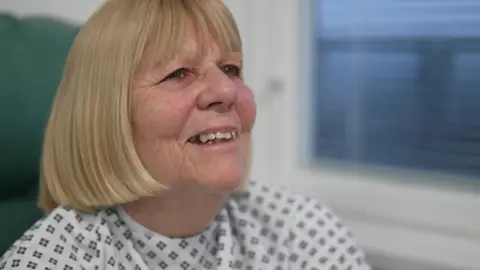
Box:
[197,68,237,113]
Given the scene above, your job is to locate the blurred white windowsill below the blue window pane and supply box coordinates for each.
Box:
[274,169,480,269]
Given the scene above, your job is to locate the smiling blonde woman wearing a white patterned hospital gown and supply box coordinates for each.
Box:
[0,0,370,270]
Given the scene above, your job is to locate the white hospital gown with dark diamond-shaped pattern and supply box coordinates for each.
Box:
[0,182,371,270]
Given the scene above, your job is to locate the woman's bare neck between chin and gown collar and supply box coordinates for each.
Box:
[123,185,228,238]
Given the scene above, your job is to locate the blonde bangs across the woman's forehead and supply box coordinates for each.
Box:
[143,0,242,71]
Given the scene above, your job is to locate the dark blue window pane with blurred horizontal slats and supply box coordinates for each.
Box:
[310,0,480,178]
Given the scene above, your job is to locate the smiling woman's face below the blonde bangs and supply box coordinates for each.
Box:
[132,29,256,193]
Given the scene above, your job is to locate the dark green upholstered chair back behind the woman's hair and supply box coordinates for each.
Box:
[0,13,78,256]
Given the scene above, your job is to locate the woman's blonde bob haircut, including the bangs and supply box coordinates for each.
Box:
[39,0,246,213]
